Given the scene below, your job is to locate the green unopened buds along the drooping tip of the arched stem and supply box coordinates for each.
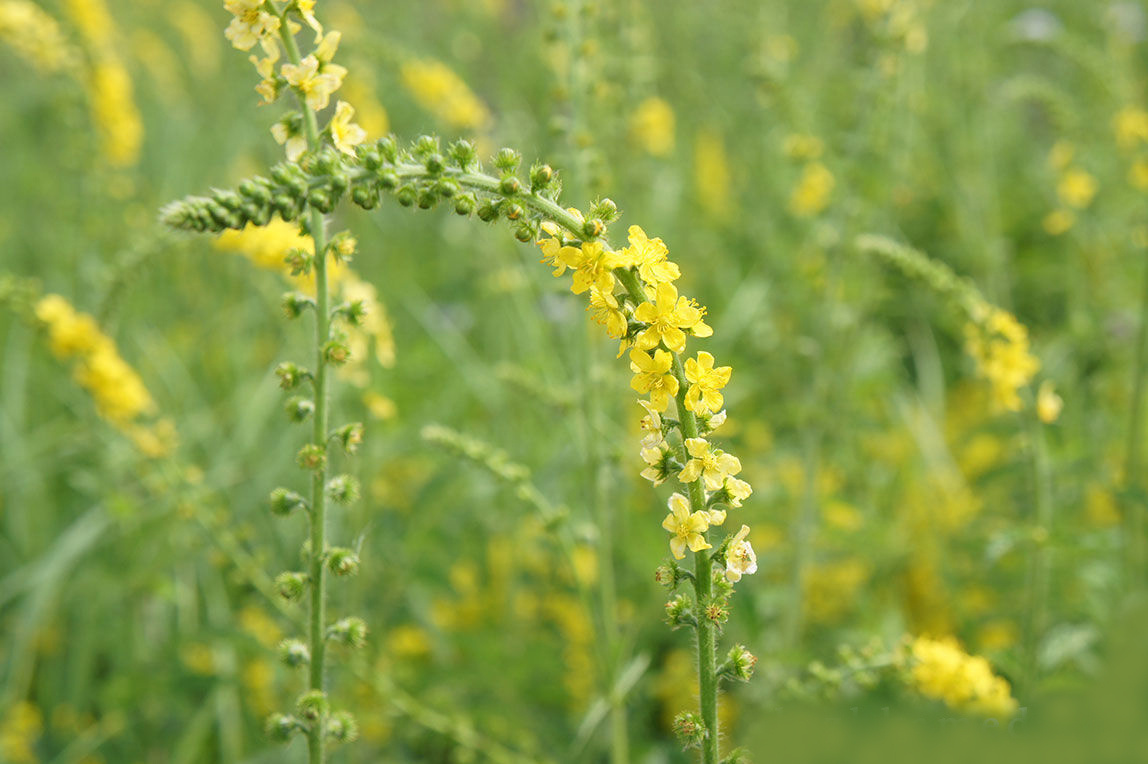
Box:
[161,135,596,244]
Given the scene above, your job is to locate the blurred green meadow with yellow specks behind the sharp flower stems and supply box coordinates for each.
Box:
[0,0,1148,764]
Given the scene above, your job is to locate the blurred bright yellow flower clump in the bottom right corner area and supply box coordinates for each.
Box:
[909,637,1017,718]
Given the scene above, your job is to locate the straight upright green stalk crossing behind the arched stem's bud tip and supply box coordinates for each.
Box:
[279,17,331,764]
